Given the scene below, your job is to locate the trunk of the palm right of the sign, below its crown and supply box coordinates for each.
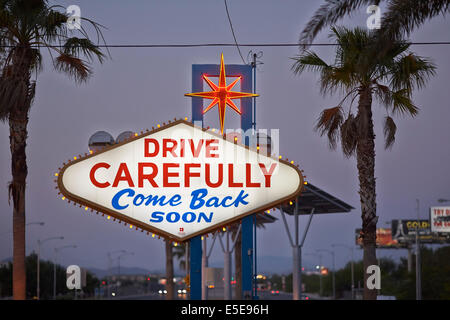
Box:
[356,88,378,300]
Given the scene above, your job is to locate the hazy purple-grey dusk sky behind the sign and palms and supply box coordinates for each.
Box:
[0,0,450,272]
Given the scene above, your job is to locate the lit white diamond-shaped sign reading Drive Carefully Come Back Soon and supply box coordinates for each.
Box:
[58,120,303,241]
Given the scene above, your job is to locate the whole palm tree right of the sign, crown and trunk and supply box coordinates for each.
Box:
[292,27,435,299]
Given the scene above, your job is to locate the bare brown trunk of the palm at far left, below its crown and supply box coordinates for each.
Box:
[9,110,28,300]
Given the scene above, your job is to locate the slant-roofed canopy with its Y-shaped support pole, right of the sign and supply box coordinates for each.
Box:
[279,183,354,300]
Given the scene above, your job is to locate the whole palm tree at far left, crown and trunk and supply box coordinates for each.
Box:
[0,0,105,299]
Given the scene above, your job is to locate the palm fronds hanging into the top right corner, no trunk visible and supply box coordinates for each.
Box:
[300,0,450,46]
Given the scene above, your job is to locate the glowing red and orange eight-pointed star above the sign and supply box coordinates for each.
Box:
[185,53,259,134]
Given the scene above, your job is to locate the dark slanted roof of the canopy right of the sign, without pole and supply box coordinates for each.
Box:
[282,182,355,215]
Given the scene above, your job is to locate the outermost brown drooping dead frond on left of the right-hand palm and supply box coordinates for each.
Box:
[315,106,344,149]
